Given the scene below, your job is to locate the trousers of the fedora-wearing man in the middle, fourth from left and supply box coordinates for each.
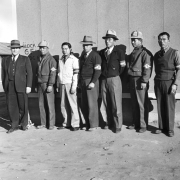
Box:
[81,79,99,128]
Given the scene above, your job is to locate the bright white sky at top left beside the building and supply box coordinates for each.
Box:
[0,0,17,43]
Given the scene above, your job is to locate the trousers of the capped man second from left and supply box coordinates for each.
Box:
[38,84,55,126]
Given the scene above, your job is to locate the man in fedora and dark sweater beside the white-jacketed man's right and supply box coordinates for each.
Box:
[80,36,101,131]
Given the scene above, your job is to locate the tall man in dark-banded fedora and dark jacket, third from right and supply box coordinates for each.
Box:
[99,30,126,133]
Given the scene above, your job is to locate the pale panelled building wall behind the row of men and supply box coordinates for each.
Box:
[16,0,180,92]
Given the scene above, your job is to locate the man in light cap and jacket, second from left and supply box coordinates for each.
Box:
[36,40,57,130]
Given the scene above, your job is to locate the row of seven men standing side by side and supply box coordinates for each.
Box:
[2,30,180,137]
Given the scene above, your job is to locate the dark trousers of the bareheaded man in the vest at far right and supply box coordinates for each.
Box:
[154,80,176,131]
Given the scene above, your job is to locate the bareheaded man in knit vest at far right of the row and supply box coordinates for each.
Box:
[154,32,180,137]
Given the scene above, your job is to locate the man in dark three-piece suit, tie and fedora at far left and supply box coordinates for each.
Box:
[2,40,33,133]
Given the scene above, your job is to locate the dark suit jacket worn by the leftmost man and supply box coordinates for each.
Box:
[2,55,33,93]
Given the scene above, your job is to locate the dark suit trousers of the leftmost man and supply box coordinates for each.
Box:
[7,81,28,128]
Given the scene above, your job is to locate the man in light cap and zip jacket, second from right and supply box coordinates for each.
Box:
[127,31,153,133]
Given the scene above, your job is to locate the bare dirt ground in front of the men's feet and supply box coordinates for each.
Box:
[0,119,180,180]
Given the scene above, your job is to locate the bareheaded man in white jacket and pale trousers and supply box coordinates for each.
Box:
[56,42,80,131]
